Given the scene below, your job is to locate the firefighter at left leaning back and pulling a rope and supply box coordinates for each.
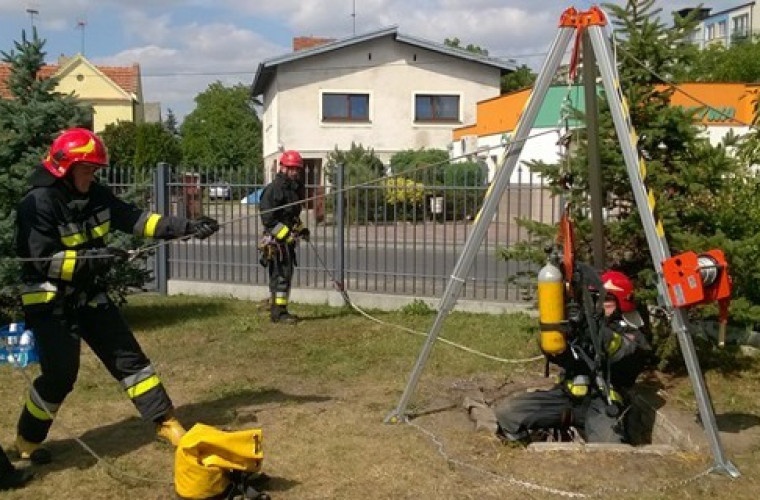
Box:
[16,128,219,464]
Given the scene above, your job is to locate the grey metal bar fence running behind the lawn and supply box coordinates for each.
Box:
[108,164,559,301]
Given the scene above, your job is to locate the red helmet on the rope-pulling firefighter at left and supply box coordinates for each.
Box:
[42,128,108,177]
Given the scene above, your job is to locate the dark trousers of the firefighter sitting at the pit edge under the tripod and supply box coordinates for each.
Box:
[496,384,625,443]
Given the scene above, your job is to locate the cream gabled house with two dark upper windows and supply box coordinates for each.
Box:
[252,26,516,184]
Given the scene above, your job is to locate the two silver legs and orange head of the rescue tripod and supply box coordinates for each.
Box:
[385,7,740,477]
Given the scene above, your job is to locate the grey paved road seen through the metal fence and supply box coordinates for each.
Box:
[170,239,528,300]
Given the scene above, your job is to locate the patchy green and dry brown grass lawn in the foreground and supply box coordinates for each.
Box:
[0,295,760,499]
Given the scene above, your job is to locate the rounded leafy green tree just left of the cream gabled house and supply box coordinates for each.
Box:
[180,82,263,180]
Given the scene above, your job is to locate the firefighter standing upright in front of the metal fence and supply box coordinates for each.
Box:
[259,150,309,324]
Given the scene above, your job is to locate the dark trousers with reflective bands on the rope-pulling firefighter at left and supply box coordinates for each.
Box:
[18,301,172,443]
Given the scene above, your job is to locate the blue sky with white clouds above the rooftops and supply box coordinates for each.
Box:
[0,0,746,120]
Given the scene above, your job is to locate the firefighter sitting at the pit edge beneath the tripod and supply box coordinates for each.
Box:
[496,268,650,443]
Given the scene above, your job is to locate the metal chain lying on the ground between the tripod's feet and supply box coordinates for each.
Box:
[404,419,715,498]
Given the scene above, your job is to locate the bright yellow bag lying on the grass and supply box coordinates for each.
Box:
[174,424,264,500]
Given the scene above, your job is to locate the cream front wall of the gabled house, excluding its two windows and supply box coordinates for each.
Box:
[262,36,500,176]
